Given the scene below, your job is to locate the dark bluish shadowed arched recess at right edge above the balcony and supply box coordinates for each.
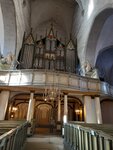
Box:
[96,46,113,85]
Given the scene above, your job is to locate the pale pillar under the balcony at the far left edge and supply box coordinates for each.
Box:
[0,91,10,120]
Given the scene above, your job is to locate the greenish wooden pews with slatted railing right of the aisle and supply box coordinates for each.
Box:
[64,123,113,150]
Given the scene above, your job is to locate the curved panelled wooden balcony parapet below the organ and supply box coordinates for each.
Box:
[0,70,113,96]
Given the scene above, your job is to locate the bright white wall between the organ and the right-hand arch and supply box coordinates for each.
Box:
[74,0,113,65]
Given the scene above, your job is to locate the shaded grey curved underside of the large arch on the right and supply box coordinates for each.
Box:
[86,8,113,66]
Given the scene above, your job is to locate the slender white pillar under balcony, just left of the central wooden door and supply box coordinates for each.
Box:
[27,93,35,122]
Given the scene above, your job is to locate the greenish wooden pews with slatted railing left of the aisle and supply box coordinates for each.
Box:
[0,121,29,150]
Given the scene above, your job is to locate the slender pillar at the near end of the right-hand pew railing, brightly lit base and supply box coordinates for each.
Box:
[63,94,68,124]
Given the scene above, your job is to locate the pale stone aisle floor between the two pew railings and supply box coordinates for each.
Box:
[23,135,64,150]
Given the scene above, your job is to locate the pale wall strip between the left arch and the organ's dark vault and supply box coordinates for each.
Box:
[13,0,30,57]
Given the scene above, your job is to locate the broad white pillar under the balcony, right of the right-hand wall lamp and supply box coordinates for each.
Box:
[84,96,97,123]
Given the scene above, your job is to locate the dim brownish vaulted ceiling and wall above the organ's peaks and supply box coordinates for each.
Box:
[31,0,77,42]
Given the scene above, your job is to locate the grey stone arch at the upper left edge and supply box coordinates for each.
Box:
[1,0,16,56]
